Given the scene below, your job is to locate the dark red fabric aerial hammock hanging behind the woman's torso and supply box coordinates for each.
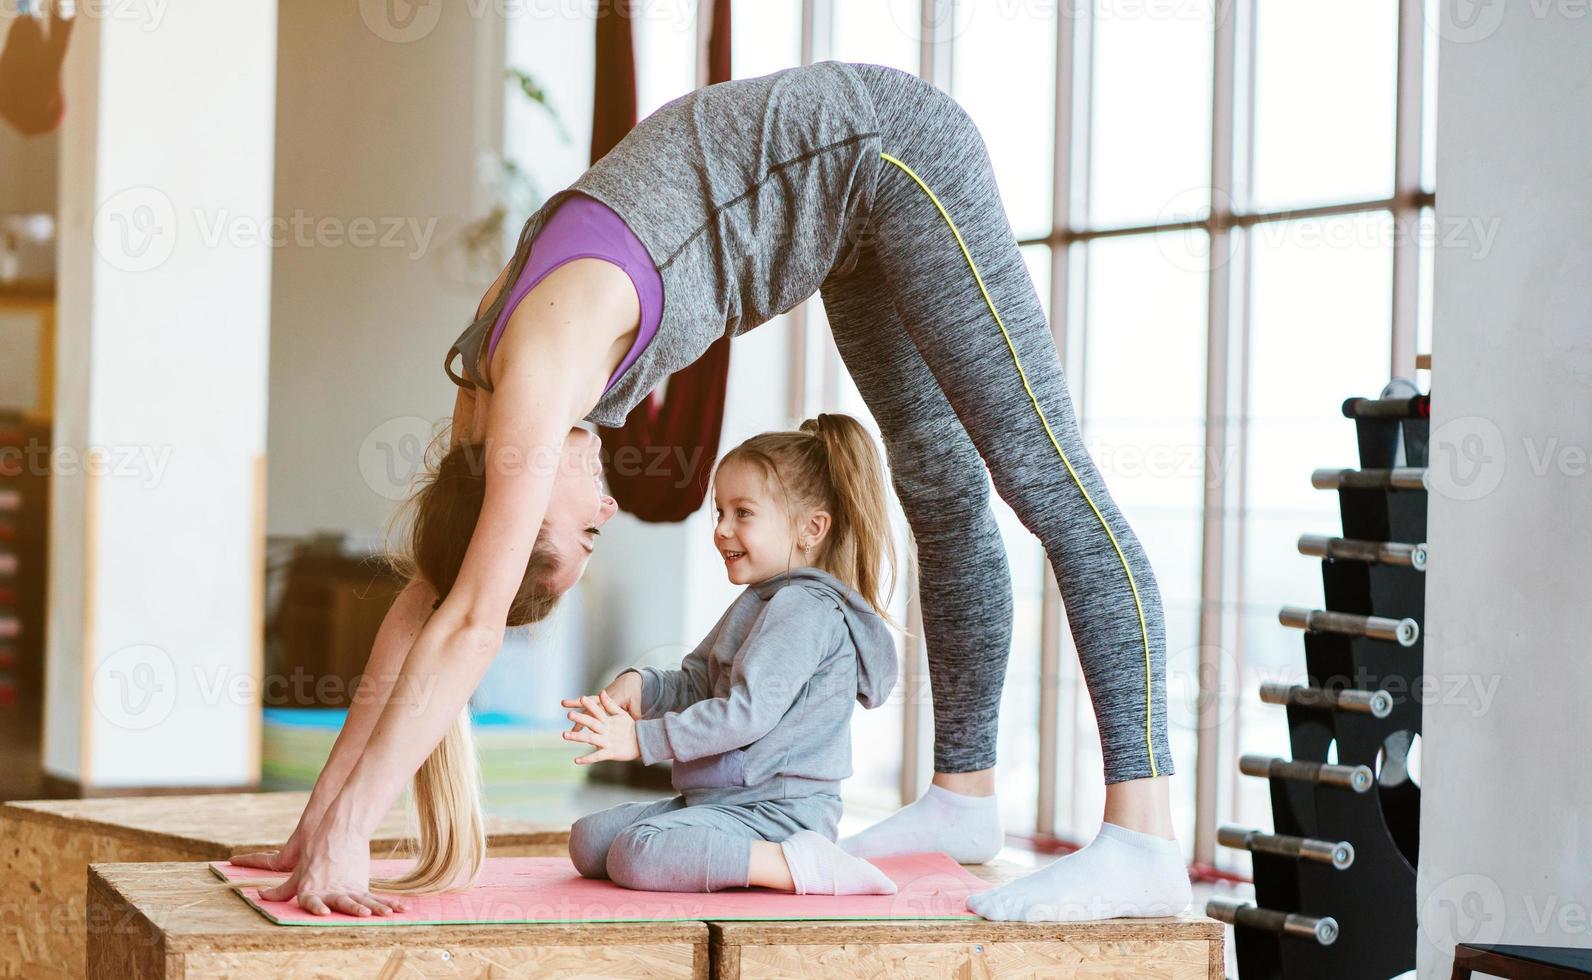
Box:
[592,0,731,523]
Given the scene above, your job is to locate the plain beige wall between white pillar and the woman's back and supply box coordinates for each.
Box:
[269,0,503,535]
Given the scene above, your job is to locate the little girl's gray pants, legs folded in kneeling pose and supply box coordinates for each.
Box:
[570,795,841,891]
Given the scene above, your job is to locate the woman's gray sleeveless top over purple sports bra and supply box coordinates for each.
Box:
[444,60,880,426]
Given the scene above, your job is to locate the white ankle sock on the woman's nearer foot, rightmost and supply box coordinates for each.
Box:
[968,824,1194,923]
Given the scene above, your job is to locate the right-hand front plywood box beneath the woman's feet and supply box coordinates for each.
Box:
[708,862,1224,980]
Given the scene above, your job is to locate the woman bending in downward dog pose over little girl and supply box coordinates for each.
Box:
[235,62,1188,920]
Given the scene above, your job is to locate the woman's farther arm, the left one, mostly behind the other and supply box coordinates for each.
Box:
[232,576,436,872]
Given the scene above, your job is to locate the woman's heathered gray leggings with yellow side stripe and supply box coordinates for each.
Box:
[820,65,1172,783]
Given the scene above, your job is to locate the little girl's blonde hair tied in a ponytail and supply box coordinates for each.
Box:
[718,414,896,620]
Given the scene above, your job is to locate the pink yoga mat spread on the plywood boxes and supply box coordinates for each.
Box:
[210,854,992,928]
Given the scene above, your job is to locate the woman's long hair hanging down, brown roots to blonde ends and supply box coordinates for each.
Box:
[371,439,559,894]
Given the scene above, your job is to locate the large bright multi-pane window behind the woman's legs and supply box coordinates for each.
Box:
[620,0,1436,870]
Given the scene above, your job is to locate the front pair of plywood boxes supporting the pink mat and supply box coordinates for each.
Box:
[88,864,1224,980]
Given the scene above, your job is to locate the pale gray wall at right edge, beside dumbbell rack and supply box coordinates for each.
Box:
[1418,0,1592,980]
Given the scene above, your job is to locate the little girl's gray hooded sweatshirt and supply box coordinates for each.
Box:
[620,568,896,805]
